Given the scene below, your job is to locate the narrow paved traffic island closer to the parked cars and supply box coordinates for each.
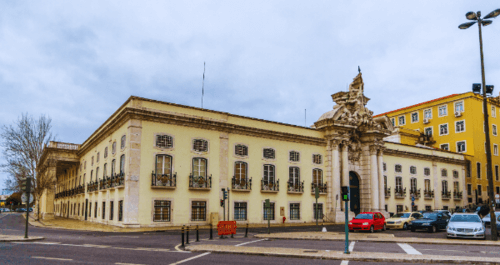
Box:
[255,232,500,247]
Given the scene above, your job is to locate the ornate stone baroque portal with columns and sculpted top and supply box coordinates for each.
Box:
[314,73,393,222]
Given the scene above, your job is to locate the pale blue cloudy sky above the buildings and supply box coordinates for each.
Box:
[0,0,500,189]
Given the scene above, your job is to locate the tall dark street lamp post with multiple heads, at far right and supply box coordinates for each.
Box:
[458,9,500,241]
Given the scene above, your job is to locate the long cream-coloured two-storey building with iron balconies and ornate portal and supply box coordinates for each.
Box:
[38,74,467,227]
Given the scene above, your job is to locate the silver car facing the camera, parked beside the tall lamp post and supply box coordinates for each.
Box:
[446,213,486,239]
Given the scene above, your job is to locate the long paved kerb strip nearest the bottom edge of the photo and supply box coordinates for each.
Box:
[186,245,500,264]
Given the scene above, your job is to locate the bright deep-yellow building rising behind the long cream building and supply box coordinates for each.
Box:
[375,92,500,204]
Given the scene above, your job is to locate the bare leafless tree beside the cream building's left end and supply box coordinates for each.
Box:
[0,113,55,219]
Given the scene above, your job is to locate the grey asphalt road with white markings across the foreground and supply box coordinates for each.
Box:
[0,214,500,265]
